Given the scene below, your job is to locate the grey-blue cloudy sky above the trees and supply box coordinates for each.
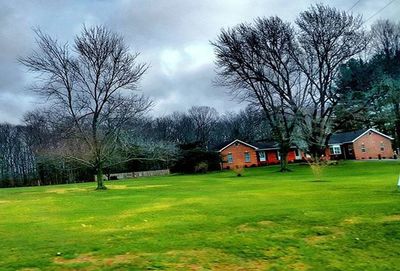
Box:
[0,0,400,123]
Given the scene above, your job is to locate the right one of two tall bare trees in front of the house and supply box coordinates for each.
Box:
[292,5,368,161]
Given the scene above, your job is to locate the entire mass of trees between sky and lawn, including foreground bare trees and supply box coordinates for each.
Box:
[0,5,400,189]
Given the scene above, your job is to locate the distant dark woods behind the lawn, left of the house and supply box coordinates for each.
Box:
[0,103,271,187]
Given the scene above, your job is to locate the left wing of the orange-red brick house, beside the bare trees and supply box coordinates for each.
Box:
[219,139,302,169]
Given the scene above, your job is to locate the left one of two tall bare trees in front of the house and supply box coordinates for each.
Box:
[212,17,308,171]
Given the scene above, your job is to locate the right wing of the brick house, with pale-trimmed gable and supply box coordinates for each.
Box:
[328,129,393,160]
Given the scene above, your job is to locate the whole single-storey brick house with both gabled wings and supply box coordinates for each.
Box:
[218,129,393,169]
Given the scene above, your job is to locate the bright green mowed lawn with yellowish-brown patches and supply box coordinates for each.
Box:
[0,161,400,270]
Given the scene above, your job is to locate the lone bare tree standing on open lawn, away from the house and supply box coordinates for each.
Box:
[19,26,151,189]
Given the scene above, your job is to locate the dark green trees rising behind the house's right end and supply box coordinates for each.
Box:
[335,20,400,148]
